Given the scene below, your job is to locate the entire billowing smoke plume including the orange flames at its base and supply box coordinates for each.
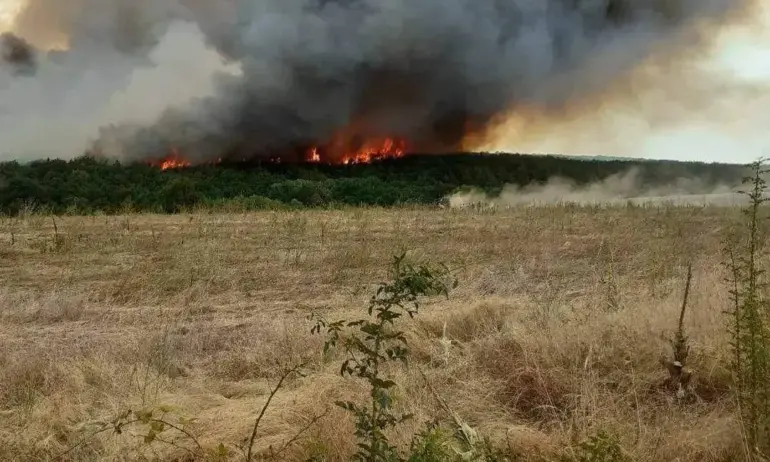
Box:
[0,0,756,166]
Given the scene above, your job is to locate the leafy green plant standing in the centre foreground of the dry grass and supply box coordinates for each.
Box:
[311,254,457,462]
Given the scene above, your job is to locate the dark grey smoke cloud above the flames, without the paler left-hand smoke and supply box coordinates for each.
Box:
[0,0,751,164]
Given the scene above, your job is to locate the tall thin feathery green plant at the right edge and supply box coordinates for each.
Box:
[726,160,770,460]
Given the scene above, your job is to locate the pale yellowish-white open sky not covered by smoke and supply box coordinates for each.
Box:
[0,0,770,163]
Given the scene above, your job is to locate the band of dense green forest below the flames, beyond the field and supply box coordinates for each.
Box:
[0,154,743,214]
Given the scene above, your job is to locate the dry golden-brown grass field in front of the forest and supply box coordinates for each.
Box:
[0,206,740,461]
